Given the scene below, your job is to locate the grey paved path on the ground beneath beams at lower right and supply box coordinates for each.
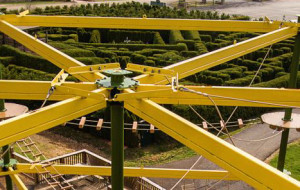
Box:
[151,112,300,190]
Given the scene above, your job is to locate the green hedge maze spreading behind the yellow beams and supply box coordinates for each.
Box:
[0,2,300,145]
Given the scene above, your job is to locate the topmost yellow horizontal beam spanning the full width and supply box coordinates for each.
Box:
[0,15,297,32]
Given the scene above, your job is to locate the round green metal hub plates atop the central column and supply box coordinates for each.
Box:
[96,70,139,90]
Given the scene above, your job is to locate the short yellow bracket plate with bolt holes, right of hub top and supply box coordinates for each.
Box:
[126,63,175,76]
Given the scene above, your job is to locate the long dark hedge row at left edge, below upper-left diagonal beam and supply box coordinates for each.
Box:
[0,45,60,73]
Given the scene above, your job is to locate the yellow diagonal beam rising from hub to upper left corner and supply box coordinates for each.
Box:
[0,20,104,81]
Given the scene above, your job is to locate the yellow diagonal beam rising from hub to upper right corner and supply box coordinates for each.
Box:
[135,27,298,84]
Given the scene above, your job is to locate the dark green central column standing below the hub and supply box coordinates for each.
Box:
[110,102,124,190]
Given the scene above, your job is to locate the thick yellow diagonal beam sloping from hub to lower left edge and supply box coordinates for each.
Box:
[0,90,107,146]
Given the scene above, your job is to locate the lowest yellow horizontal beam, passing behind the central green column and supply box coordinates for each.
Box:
[14,163,238,180]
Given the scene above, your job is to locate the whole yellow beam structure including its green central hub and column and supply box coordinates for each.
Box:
[0,12,300,190]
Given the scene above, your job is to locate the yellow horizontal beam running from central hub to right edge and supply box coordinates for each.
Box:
[114,85,300,107]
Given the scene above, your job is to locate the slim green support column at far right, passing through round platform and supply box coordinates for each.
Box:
[277,16,300,171]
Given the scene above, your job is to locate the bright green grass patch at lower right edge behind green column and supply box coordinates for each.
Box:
[270,141,300,180]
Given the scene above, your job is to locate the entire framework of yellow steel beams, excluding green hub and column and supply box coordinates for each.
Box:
[0,14,300,190]
